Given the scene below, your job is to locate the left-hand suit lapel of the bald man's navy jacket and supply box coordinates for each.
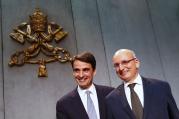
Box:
[117,84,135,119]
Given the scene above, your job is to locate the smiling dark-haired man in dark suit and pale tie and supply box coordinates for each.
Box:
[56,52,113,119]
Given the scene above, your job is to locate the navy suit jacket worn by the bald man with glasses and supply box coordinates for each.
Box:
[106,78,179,119]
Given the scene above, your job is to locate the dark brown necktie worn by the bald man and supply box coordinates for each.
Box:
[129,83,143,119]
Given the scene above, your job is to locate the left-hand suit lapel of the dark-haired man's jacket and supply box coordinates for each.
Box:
[72,89,89,119]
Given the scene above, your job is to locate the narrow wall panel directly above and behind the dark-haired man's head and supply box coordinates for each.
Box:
[72,0,110,85]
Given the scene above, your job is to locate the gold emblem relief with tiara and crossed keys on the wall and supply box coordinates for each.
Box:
[9,8,72,77]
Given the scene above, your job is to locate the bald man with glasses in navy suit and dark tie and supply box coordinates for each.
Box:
[106,49,179,119]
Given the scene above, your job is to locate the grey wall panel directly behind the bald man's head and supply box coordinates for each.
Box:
[97,0,164,86]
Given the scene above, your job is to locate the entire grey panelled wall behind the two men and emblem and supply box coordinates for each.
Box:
[0,0,179,119]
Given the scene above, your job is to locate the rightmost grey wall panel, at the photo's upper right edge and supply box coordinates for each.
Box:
[148,0,179,105]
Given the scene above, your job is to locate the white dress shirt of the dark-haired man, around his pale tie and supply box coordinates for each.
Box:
[77,84,100,119]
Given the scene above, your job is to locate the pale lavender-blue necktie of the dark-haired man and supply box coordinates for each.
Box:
[86,91,97,119]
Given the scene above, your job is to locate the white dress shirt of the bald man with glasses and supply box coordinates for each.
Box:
[124,74,144,109]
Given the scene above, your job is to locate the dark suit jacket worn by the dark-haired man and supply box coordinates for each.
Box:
[56,85,113,119]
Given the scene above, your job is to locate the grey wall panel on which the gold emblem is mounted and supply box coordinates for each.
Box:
[2,0,76,119]
